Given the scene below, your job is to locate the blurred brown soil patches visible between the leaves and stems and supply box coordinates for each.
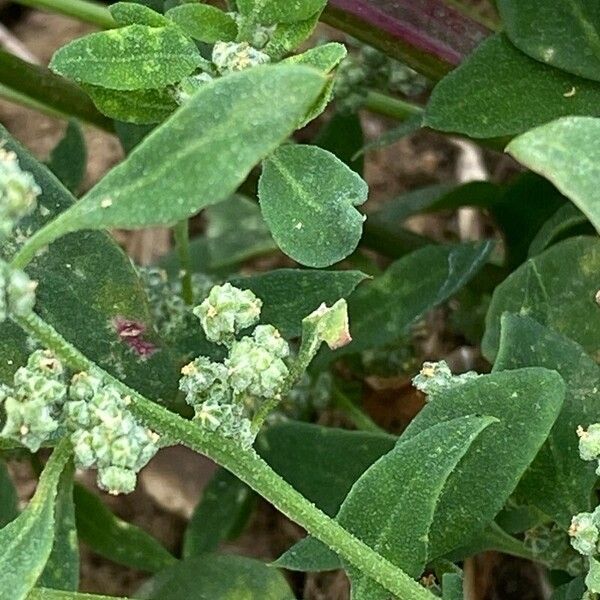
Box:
[0,0,545,600]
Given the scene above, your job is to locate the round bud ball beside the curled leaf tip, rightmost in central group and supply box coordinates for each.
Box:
[225,337,289,398]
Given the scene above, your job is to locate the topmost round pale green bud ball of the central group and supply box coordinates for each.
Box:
[194,283,262,345]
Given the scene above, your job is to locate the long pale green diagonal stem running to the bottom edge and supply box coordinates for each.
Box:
[13,314,435,600]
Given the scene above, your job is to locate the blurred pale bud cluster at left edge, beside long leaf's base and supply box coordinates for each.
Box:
[0,148,42,237]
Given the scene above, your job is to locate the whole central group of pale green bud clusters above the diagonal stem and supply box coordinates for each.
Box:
[179,283,290,447]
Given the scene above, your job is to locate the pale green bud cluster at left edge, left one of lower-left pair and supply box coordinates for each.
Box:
[0,350,67,452]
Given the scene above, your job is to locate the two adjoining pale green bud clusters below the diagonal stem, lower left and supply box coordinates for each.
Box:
[0,350,158,494]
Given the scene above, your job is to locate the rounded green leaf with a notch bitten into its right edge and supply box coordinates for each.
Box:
[258,145,369,267]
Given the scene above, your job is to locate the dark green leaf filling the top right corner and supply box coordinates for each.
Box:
[498,0,600,81]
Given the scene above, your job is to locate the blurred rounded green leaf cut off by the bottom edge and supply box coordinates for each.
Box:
[138,554,294,600]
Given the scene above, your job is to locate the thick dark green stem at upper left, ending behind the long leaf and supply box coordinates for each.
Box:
[0,50,114,132]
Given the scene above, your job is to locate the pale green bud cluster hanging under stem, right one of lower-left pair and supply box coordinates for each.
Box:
[63,373,158,494]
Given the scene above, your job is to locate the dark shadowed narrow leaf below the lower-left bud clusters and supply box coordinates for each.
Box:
[74,485,175,573]
